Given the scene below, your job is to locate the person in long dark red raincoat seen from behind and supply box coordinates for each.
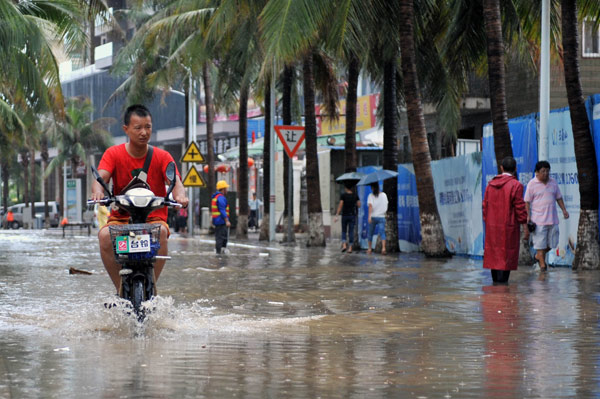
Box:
[483,157,527,283]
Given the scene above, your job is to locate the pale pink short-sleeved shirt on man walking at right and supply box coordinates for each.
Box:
[524,177,562,226]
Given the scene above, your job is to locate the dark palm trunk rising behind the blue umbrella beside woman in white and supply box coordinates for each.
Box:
[383,59,399,253]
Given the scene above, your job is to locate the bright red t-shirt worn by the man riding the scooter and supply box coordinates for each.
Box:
[98,144,181,222]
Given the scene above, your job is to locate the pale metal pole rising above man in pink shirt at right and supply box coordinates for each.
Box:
[538,0,550,160]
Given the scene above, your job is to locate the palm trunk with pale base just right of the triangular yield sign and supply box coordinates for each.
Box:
[302,52,325,247]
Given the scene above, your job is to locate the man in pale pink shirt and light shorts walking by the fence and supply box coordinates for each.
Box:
[525,161,569,271]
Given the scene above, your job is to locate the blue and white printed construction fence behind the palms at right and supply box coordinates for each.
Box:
[358,94,600,266]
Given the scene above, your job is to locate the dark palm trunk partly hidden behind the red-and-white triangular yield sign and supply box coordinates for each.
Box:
[281,65,296,242]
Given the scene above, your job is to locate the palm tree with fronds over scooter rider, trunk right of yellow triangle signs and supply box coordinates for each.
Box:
[111,0,225,203]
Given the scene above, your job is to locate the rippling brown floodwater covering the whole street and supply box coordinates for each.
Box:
[0,230,600,398]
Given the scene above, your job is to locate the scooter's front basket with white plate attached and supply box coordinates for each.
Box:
[108,223,161,261]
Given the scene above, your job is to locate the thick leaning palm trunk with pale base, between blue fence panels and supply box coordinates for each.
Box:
[400,0,449,257]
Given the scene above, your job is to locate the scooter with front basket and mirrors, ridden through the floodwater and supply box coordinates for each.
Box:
[87,162,181,322]
